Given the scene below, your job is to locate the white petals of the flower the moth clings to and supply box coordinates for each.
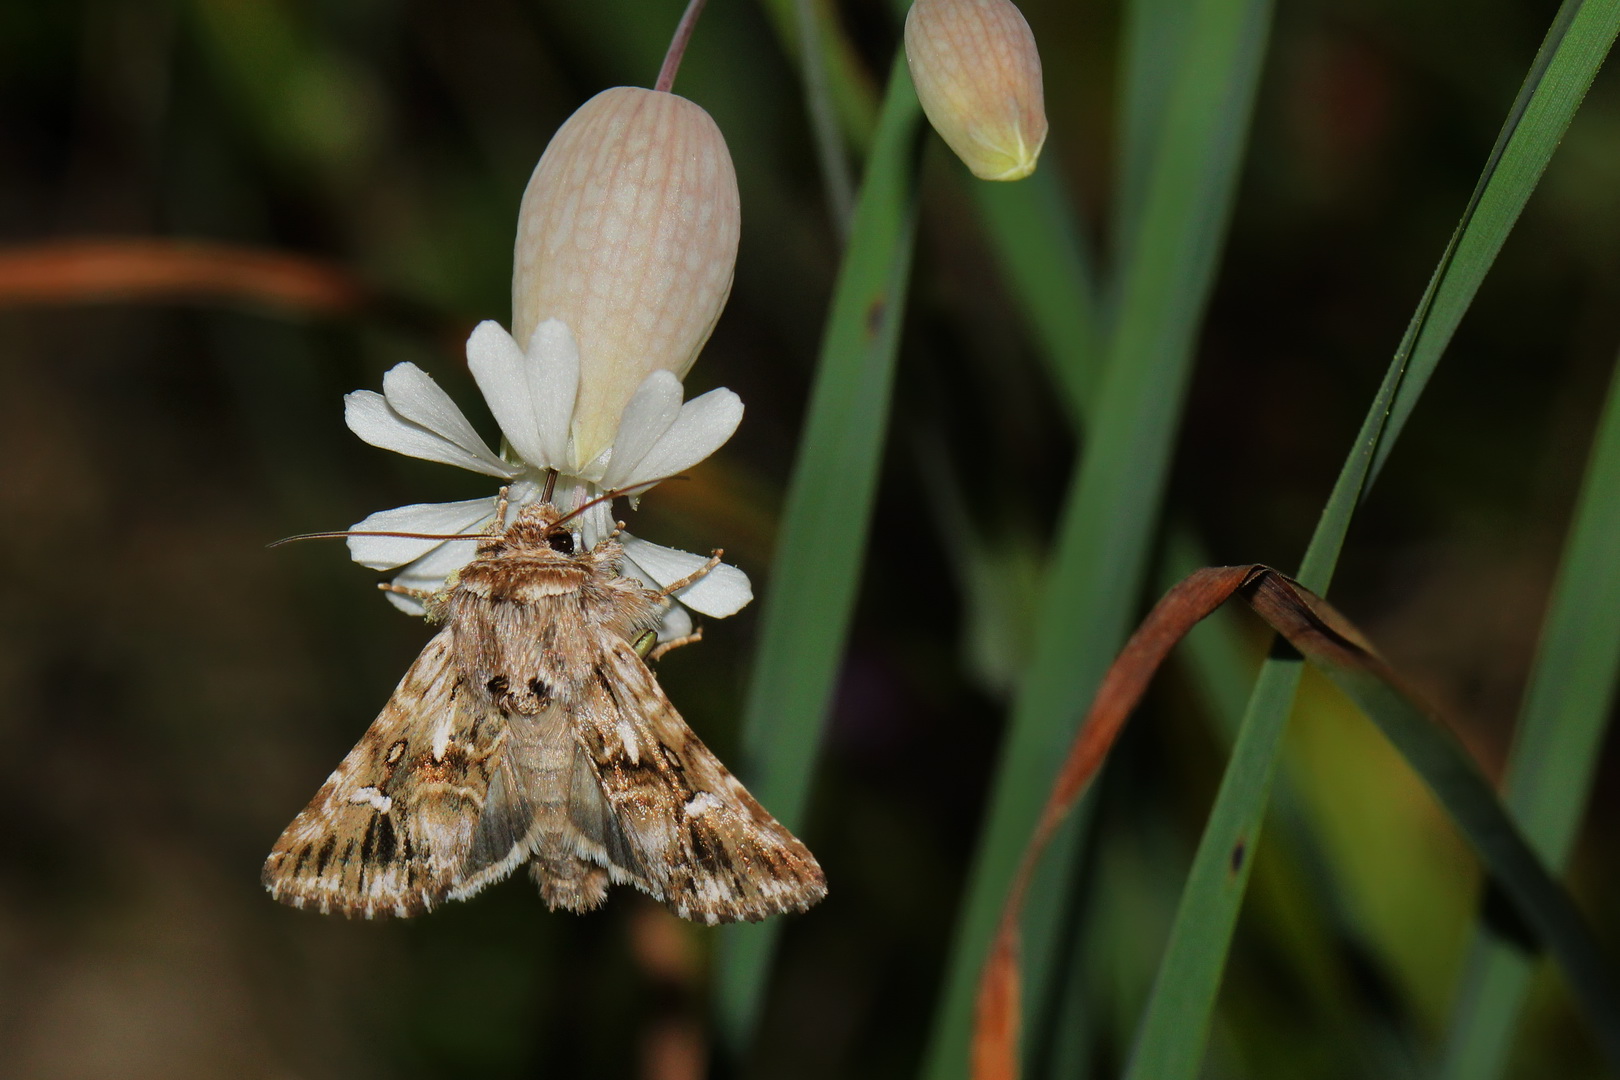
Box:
[343,319,753,640]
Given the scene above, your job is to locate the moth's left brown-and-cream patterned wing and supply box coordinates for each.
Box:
[264,627,510,918]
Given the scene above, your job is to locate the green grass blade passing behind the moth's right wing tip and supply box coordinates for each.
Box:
[716,57,922,1046]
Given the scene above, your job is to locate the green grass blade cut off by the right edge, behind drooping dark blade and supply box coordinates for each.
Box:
[1442,351,1620,1080]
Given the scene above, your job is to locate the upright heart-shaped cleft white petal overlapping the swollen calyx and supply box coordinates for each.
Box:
[467,319,580,468]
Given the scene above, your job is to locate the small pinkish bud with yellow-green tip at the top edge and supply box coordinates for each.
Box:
[906,0,1047,180]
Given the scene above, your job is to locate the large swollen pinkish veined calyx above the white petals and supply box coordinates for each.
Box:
[512,86,742,466]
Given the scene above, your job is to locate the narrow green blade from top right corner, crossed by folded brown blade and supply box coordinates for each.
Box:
[1128,0,1620,1080]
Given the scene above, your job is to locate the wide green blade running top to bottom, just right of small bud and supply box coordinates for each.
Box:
[927,0,1270,1080]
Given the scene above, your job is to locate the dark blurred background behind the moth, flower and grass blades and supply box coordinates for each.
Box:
[0,0,1620,1080]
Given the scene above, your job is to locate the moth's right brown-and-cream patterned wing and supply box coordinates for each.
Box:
[575,640,826,923]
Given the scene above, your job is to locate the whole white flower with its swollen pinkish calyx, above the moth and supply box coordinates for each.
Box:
[347,86,753,640]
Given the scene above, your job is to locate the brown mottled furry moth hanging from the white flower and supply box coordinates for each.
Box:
[264,502,826,925]
